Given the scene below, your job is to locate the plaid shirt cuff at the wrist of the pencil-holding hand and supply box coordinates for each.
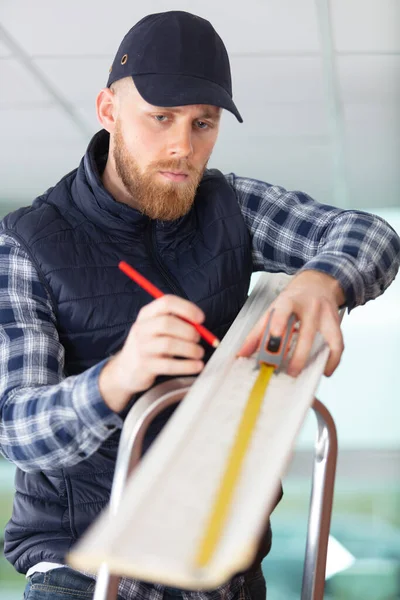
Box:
[72,358,123,439]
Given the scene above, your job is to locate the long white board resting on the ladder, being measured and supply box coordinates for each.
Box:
[69,275,329,590]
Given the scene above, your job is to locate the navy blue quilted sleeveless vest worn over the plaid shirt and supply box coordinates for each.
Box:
[2,131,252,573]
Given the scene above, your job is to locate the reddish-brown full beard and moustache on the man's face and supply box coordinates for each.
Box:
[113,121,207,221]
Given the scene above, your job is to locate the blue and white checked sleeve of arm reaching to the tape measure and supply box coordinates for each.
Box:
[225,173,400,309]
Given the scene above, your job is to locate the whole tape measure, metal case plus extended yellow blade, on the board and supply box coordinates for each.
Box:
[195,311,296,567]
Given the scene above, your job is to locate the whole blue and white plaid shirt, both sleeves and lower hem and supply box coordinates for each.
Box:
[0,173,400,600]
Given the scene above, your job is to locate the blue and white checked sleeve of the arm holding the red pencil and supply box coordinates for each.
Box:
[0,234,122,471]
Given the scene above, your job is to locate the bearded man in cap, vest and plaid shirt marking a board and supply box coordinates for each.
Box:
[0,11,400,600]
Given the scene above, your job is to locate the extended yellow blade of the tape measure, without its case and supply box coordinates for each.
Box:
[195,364,275,567]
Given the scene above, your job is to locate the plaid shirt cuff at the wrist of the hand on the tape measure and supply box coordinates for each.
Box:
[298,252,365,311]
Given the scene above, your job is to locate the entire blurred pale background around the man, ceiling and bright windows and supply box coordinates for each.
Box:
[0,0,400,600]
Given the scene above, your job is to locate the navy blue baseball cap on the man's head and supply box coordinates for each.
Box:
[107,10,243,123]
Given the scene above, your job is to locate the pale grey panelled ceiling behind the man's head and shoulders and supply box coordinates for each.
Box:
[0,0,400,212]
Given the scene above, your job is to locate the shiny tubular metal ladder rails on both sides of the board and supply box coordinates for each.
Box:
[93,377,337,600]
